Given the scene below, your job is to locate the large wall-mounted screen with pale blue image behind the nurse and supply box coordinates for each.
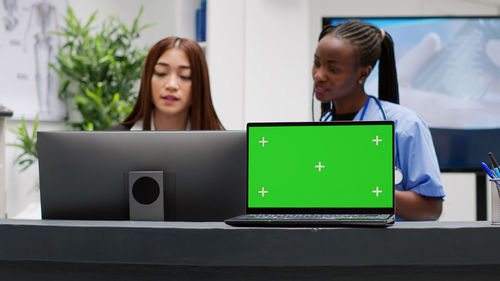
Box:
[323,17,500,129]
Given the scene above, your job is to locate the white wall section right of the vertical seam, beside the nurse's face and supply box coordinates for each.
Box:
[245,0,311,122]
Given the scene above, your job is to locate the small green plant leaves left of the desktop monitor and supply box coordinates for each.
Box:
[7,116,38,171]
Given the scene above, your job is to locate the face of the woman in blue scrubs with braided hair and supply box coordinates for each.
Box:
[312,35,364,102]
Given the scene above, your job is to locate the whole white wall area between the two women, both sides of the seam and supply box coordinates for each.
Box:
[207,0,310,129]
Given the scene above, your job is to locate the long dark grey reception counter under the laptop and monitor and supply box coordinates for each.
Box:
[0,220,500,280]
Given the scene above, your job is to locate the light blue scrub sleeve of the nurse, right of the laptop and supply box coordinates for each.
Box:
[396,118,445,198]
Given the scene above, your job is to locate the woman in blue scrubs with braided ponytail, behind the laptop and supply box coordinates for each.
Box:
[312,21,445,220]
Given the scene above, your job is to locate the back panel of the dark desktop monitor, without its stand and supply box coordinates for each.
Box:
[38,131,247,221]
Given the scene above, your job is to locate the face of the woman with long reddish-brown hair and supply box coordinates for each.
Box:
[151,48,192,115]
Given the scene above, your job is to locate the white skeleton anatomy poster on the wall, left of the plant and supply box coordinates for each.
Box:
[0,0,67,120]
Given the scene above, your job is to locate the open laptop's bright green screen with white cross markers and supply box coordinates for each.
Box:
[247,121,394,208]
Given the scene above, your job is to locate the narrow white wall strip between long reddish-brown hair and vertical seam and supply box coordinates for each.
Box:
[206,0,246,130]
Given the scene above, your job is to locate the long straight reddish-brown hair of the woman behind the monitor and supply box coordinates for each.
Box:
[122,37,224,130]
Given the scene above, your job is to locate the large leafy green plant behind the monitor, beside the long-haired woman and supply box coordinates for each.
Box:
[50,6,152,130]
